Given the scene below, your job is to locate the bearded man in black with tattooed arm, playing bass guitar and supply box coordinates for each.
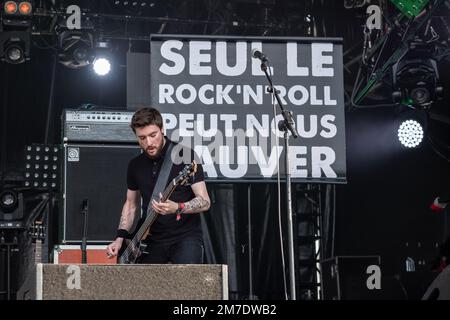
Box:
[107,108,210,264]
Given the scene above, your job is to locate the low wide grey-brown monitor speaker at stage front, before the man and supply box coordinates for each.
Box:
[17,264,228,300]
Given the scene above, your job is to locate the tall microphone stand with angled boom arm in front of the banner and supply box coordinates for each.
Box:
[261,58,298,300]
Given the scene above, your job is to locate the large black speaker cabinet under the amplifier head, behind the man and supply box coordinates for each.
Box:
[60,144,141,243]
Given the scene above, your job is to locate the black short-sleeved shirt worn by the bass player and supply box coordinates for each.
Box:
[127,138,205,245]
